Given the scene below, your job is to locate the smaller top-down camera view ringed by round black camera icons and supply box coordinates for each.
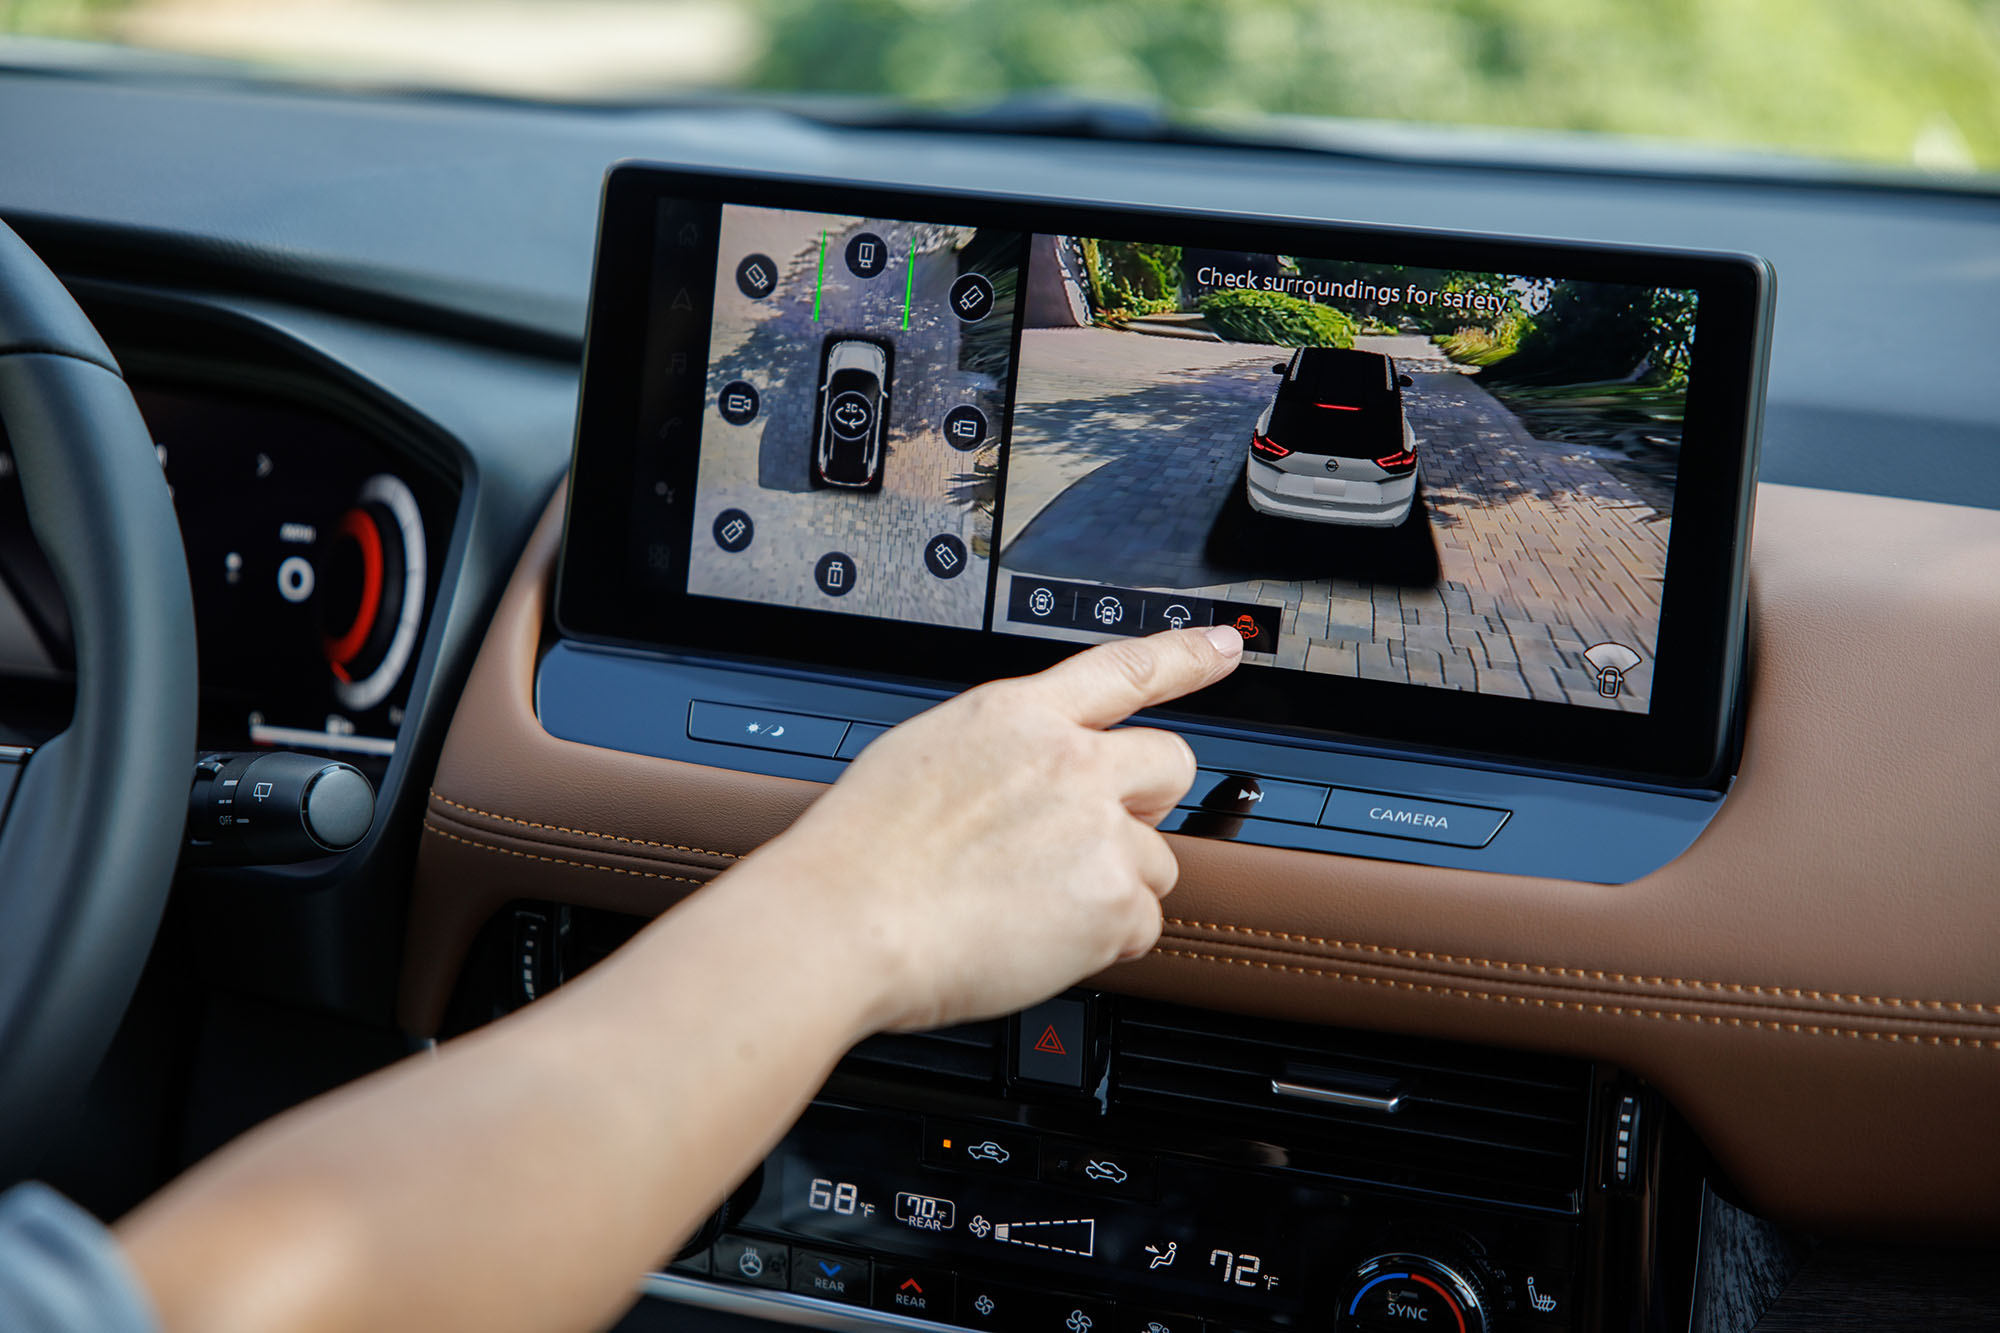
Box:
[688,204,1022,628]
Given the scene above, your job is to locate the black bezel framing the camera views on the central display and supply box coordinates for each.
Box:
[556,164,1770,787]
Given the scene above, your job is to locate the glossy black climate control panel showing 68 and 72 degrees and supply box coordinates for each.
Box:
[674,1101,1576,1333]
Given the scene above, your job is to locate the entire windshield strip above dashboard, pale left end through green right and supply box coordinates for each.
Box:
[0,0,2000,172]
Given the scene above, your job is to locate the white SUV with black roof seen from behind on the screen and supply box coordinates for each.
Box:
[1244,346,1420,528]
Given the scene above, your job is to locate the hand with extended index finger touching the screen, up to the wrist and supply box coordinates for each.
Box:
[746,626,1242,1029]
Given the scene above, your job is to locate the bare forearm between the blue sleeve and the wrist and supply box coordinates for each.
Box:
[120,847,882,1333]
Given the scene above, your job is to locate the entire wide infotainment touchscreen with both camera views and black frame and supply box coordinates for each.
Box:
[558,168,1768,781]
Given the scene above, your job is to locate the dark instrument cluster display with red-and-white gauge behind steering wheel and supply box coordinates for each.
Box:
[134,384,452,769]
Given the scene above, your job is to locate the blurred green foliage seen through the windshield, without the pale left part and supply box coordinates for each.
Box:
[752,0,2000,170]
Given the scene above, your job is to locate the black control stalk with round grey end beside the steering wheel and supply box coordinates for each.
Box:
[188,751,374,865]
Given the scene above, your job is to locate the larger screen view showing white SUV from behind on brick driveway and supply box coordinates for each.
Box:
[994,236,1694,725]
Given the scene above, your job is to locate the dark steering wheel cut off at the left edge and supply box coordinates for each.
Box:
[0,224,196,1187]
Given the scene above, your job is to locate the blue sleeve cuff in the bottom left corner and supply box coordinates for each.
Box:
[0,1185,158,1333]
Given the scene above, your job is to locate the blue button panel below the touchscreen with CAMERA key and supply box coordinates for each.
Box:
[536,638,1724,885]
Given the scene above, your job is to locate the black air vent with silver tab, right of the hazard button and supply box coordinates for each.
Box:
[1112,1001,1590,1209]
